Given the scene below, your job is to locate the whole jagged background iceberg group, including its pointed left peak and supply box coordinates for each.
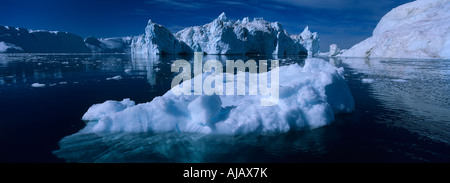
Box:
[131,13,319,56]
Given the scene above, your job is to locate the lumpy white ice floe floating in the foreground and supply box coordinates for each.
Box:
[74,58,354,134]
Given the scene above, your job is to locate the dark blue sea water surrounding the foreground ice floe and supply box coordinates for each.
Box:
[0,54,450,162]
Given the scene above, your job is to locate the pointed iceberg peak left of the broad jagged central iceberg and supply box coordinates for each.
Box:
[131,20,192,55]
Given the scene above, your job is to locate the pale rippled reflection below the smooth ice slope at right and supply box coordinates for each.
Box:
[338,58,450,143]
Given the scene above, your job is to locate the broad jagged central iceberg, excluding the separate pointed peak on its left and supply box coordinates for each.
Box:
[175,13,318,55]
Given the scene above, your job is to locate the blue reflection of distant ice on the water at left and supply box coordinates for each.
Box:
[0,54,165,86]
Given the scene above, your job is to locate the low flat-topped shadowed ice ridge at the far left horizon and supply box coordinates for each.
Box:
[0,26,91,53]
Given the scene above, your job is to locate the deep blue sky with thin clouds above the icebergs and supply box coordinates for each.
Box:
[0,0,411,51]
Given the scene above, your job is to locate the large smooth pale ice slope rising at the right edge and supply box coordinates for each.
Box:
[342,0,450,58]
